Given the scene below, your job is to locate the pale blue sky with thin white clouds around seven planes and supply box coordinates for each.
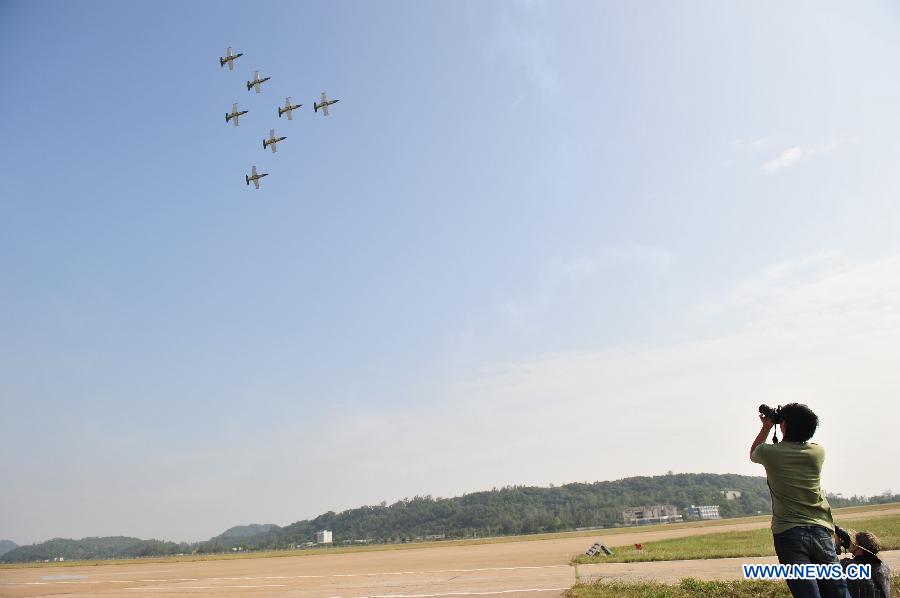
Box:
[0,0,900,544]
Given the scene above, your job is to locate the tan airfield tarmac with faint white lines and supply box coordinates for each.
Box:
[0,509,900,598]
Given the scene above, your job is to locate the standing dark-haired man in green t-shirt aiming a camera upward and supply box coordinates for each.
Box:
[750,403,850,598]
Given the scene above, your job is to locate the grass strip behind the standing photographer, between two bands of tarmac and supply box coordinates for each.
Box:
[573,513,900,564]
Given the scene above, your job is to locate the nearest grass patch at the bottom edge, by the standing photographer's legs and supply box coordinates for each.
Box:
[565,575,900,598]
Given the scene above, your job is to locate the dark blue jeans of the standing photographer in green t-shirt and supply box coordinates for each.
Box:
[772,525,850,598]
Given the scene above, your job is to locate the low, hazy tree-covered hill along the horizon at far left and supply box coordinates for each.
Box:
[0,536,195,563]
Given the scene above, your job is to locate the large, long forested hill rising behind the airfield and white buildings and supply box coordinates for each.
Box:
[200,473,771,552]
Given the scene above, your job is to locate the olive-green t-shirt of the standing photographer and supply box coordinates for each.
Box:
[750,441,834,534]
